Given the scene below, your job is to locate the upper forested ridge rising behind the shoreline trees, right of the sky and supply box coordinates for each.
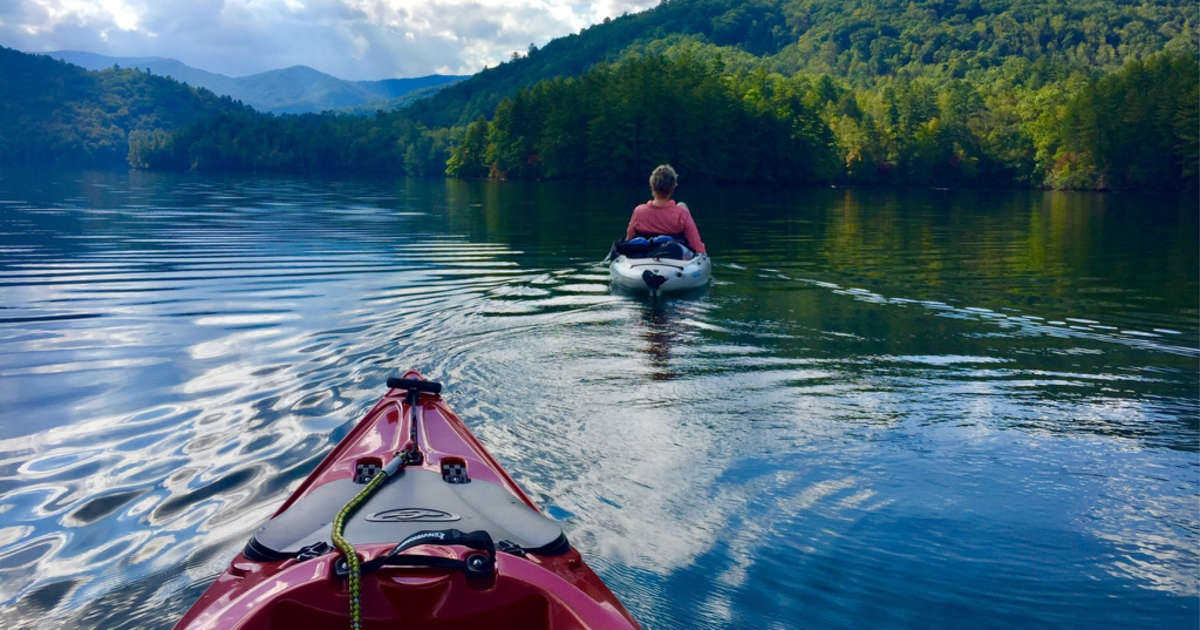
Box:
[412,0,1200,126]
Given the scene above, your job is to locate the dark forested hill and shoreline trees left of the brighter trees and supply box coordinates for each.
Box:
[0,47,450,175]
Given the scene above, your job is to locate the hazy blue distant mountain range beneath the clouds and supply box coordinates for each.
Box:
[46,50,466,114]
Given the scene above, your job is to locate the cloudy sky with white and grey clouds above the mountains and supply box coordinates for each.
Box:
[0,0,658,79]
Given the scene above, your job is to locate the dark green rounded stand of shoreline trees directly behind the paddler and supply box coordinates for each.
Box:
[446,56,836,182]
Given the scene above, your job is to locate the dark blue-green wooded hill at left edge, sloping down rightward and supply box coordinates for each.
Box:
[0,47,250,166]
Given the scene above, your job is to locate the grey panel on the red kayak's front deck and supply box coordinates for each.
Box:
[244,469,570,562]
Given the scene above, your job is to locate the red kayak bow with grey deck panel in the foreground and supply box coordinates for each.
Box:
[175,371,638,630]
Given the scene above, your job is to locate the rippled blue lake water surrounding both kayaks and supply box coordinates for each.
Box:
[0,172,1200,629]
